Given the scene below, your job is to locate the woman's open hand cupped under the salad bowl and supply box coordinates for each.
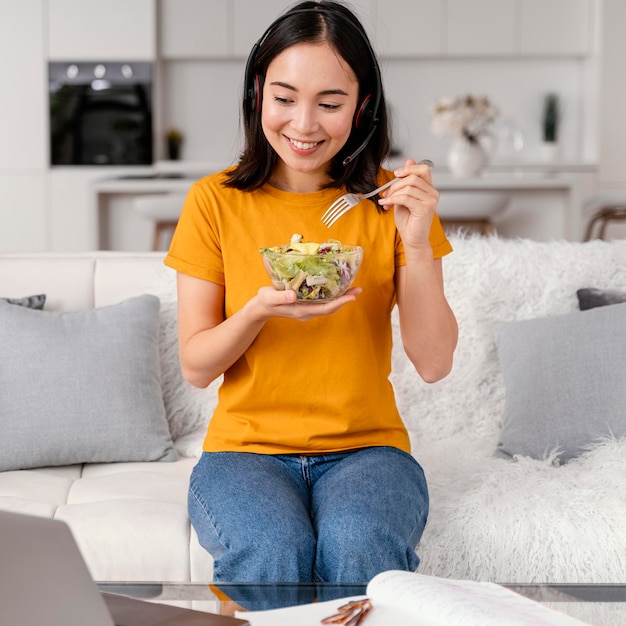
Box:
[255,287,362,322]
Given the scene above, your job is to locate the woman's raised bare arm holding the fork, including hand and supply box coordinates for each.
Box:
[381,161,458,382]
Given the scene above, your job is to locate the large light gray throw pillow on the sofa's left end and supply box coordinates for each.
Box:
[0,295,177,471]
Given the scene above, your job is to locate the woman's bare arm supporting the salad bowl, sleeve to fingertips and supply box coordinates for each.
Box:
[177,272,360,387]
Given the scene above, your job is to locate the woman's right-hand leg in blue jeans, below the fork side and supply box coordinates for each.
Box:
[316,448,429,582]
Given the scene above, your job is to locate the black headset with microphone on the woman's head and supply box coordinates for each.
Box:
[244,6,383,165]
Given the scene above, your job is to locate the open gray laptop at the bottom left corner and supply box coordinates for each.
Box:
[0,511,248,626]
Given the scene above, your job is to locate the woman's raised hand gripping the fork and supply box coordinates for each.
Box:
[379,159,439,249]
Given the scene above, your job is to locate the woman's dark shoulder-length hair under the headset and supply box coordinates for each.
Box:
[225,0,389,192]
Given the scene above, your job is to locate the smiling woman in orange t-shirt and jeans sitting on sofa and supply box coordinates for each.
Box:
[166,1,457,582]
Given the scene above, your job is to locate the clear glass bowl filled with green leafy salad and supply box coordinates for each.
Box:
[259,234,363,302]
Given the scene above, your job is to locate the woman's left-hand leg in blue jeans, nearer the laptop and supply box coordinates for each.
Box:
[188,455,315,581]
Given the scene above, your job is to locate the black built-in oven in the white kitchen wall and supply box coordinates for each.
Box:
[48,62,153,165]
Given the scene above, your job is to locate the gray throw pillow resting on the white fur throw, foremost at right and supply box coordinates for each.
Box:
[494,303,626,462]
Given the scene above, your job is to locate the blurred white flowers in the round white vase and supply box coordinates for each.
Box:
[432,94,499,142]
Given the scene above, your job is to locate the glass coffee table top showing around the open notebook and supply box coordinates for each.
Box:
[97,582,626,626]
